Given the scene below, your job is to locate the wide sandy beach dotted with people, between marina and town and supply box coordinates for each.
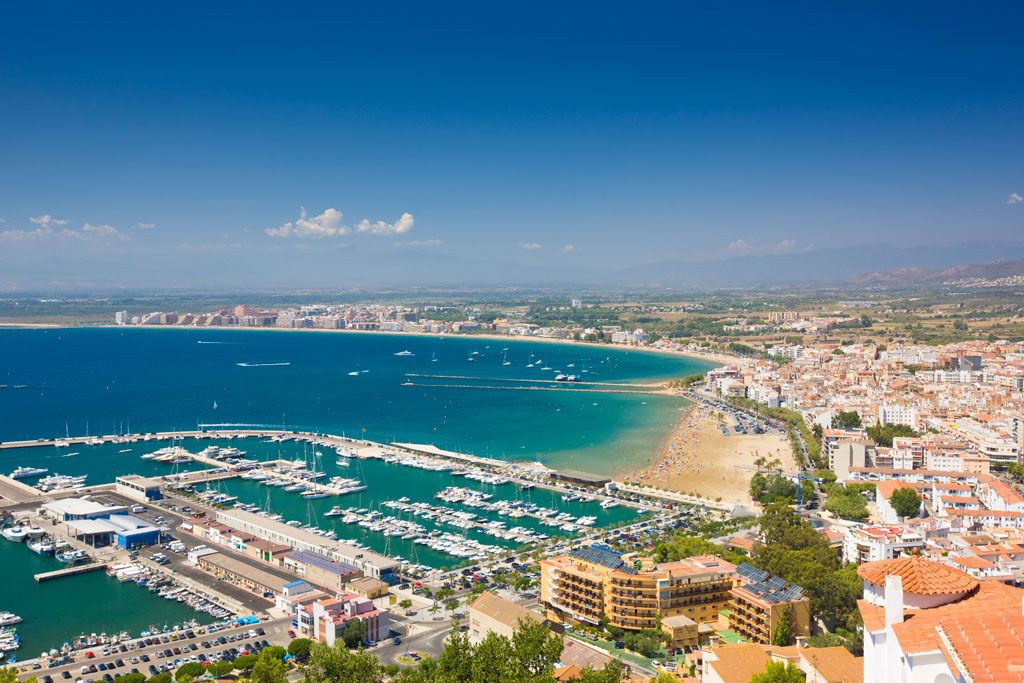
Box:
[625,404,797,505]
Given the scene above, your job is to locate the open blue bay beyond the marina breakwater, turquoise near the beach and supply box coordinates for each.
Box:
[0,328,710,473]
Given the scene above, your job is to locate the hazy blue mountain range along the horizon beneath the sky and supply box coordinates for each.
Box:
[6,243,1024,292]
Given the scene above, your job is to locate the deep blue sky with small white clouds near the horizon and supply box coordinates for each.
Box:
[0,1,1024,289]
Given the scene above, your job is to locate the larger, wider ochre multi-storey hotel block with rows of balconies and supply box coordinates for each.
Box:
[541,546,737,644]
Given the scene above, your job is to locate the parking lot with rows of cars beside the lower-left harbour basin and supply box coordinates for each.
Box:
[18,617,292,683]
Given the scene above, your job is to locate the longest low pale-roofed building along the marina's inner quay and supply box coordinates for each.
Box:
[216,509,401,585]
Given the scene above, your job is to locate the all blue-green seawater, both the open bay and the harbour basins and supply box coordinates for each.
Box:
[0,329,710,658]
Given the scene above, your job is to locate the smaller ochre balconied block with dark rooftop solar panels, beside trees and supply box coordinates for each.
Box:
[722,562,811,643]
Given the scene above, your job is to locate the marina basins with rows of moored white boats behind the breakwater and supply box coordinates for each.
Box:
[0,428,655,651]
